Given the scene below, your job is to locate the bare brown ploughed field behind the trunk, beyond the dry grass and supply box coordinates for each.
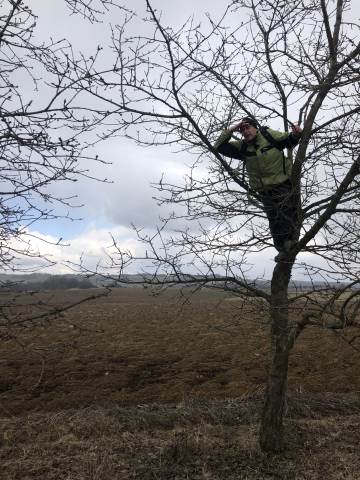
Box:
[0,288,360,414]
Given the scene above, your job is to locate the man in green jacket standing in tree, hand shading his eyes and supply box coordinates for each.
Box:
[214,117,302,262]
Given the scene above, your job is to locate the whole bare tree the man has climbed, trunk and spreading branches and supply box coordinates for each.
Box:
[64,0,360,451]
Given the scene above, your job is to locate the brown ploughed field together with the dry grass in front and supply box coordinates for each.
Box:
[0,288,360,480]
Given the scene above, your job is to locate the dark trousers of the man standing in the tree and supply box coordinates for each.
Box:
[259,180,297,252]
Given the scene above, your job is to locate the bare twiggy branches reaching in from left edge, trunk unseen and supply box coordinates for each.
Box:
[0,0,125,338]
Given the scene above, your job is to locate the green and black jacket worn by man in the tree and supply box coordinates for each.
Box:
[214,128,299,191]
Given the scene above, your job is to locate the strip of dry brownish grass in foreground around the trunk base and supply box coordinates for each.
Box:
[0,394,360,480]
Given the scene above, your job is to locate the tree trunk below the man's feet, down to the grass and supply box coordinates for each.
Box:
[260,262,292,453]
